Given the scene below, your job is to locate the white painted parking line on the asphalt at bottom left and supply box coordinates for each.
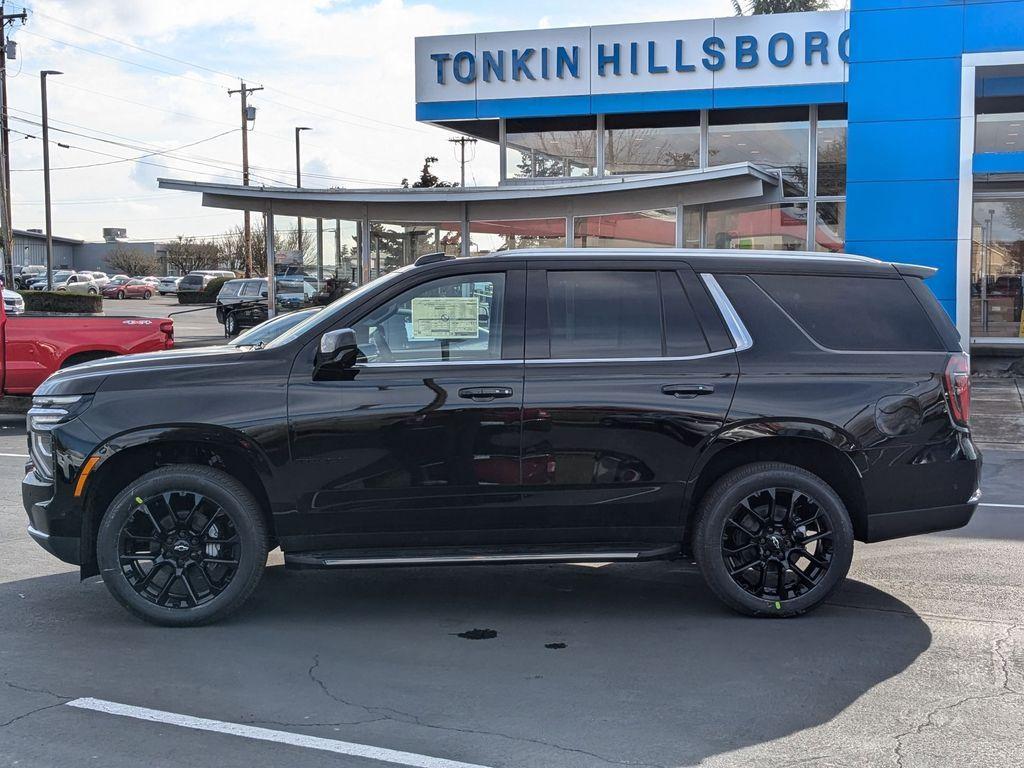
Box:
[67,698,486,768]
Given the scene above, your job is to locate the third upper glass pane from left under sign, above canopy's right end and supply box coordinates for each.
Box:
[708,108,810,197]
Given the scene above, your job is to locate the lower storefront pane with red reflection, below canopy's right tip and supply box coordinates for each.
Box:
[707,203,807,251]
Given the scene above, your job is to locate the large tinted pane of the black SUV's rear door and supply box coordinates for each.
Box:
[548,270,663,359]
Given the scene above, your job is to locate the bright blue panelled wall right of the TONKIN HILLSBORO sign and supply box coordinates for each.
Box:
[847,0,1024,317]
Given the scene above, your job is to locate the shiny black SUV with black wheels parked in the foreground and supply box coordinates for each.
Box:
[24,249,981,625]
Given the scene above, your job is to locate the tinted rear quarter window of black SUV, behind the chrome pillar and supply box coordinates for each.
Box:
[753,274,945,351]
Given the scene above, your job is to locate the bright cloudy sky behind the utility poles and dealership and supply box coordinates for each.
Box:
[6,0,839,240]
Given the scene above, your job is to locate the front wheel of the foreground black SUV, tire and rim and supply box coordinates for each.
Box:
[96,465,267,627]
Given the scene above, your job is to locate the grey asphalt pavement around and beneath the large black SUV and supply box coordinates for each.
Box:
[0,416,1024,768]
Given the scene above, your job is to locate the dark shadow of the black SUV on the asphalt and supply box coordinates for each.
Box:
[0,563,932,767]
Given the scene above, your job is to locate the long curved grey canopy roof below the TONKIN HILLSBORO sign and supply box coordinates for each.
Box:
[159,163,781,222]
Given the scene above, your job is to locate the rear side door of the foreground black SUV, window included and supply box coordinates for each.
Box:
[522,260,738,543]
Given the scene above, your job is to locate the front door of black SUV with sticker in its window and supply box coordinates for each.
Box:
[279,265,525,550]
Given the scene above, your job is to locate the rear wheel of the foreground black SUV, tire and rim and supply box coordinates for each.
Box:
[693,462,853,617]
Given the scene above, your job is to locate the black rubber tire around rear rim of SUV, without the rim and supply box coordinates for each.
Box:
[693,464,853,616]
